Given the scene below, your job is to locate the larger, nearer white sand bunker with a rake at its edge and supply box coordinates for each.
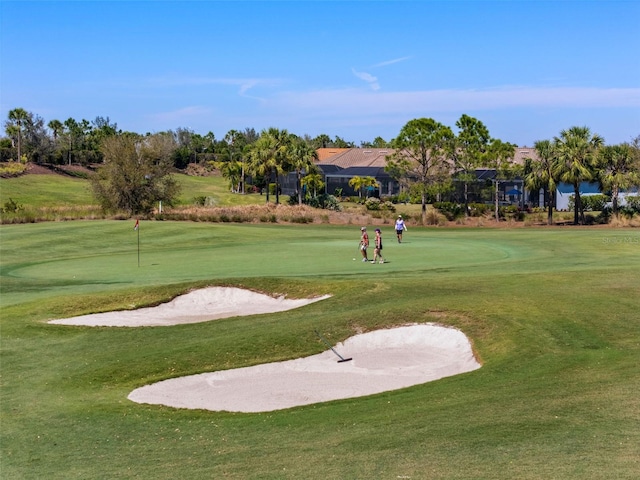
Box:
[128,324,480,412]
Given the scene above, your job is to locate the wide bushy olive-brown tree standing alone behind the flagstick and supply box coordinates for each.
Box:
[91,133,180,215]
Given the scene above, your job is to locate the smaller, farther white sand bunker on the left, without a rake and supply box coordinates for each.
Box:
[49,287,330,327]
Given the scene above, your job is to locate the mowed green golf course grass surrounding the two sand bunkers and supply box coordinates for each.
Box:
[0,221,640,479]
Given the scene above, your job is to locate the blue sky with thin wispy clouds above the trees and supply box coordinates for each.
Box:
[0,0,640,146]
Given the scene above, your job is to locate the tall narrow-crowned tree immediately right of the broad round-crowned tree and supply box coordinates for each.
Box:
[448,114,491,216]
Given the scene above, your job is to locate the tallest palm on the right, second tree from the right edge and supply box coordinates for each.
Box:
[554,127,604,225]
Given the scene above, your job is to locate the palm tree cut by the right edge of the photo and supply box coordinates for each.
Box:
[598,143,640,215]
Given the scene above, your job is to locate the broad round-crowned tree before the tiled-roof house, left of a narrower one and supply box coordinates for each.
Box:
[386,118,454,223]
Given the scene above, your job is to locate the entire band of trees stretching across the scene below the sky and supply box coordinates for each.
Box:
[5,108,640,224]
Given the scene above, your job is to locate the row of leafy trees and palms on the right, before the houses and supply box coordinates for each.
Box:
[386,115,640,224]
